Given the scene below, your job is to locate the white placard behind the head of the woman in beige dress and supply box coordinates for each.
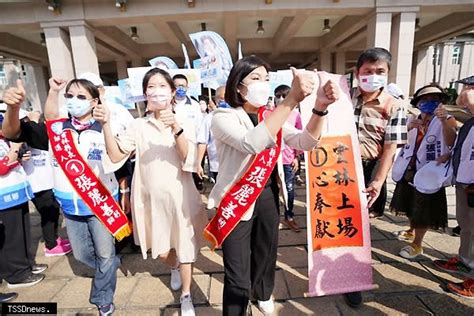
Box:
[127,67,201,97]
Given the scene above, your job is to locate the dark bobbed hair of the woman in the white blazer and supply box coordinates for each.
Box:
[225,55,271,108]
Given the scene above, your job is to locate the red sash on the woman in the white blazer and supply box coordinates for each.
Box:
[204,108,282,249]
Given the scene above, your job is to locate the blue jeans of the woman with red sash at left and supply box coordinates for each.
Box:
[65,215,120,307]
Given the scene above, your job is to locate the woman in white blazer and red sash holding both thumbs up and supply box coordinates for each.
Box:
[205,56,339,315]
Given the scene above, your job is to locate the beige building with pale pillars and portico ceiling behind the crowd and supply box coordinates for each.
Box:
[0,0,474,110]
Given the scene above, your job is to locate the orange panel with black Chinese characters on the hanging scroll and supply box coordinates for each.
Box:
[308,135,363,251]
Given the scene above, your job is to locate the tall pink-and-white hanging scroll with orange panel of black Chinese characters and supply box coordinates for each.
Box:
[300,72,374,296]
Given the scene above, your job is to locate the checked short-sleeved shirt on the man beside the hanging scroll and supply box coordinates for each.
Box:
[352,89,407,160]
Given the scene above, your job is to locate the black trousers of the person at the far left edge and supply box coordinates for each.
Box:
[0,203,34,283]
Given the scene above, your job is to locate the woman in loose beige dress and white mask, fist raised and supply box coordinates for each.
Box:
[94,68,207,315]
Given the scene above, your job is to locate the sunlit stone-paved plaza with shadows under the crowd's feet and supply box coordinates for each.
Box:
[0,178,474,316]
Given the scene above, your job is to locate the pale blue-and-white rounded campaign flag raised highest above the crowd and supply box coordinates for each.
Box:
[189,31,233,89]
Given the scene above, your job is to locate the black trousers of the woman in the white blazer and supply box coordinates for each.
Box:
[222,187,280,316]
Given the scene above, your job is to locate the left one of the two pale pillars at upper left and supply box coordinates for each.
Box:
[44,27,75,80]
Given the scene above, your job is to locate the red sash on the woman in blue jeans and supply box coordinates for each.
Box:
[46,119,132,241]
